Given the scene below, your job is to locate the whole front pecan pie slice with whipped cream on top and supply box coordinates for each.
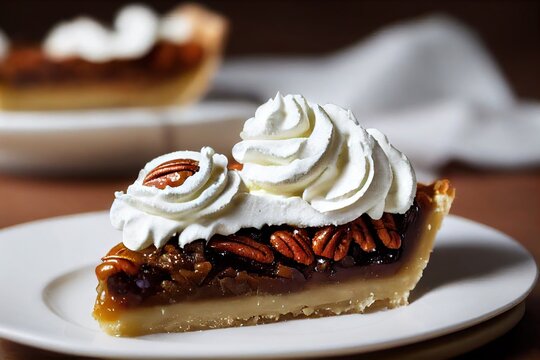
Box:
[93,94,454,336]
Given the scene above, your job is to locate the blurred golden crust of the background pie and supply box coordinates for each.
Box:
[0,4,227,110]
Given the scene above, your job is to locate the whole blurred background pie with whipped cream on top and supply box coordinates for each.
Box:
[0,4,227,110]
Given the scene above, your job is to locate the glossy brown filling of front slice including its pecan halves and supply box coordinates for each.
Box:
[96,202,421,316]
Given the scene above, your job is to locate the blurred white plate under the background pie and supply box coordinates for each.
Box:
[0,101,255,175]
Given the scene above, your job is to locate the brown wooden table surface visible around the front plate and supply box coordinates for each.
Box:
[0,166,540,360]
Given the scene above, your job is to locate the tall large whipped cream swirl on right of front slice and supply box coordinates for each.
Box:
[232,93,416,218]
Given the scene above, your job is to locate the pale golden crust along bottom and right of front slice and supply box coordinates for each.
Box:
[99,185,454,336]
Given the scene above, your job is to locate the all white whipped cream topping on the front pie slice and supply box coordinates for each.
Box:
[111,94,416,250]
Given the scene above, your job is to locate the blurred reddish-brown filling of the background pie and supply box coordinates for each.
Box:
[0,41,204,87]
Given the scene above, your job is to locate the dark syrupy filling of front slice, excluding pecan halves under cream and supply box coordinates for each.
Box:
[95,198,428,318]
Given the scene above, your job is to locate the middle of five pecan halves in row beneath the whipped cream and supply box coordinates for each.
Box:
[312,225,352,261]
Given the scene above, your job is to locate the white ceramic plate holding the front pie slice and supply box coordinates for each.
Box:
[0,212,537,359]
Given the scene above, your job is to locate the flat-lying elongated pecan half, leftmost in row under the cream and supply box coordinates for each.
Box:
[208,235,274,264]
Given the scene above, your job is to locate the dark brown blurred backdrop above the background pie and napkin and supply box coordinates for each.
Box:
[0,0,540,99]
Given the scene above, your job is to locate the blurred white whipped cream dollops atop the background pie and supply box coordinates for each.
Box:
[43,5,192,62]
